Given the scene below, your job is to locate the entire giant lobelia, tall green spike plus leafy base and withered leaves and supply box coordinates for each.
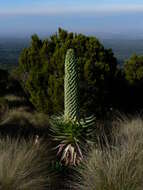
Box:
[51,49,95,165]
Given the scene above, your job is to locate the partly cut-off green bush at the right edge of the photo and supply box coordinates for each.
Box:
[123,54,143,112]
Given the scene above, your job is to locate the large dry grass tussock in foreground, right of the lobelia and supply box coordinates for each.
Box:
[74,118,143,190]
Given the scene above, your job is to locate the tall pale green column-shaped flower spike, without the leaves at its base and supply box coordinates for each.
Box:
[64,49,79,121]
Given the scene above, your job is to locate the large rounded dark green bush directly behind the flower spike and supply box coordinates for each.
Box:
[18,29,117,114]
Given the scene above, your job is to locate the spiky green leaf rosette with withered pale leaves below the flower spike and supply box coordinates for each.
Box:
[51,116,94,166]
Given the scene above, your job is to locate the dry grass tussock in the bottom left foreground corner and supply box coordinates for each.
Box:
[0,137,50,190]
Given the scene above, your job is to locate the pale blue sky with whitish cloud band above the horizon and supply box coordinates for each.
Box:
[0,0,143,37]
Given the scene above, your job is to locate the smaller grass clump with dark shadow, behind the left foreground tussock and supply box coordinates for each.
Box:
[0,108,49,141]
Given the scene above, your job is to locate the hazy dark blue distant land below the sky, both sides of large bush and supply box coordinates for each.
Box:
[0,38,143,69]
